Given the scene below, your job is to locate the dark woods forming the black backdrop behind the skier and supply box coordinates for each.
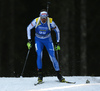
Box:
[0,0,100,77]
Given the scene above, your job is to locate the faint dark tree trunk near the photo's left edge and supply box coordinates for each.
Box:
[9,0,15,76]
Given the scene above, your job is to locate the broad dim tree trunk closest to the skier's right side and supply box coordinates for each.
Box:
[61,8,69,75]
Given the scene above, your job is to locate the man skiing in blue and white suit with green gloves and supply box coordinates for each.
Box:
[27,10,65,82]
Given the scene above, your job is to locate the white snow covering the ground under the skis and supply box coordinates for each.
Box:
[0,76,100,91]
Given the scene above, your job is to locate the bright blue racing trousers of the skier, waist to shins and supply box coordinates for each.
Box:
[35,37,60,71]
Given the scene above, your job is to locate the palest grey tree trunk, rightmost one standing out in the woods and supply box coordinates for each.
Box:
[81,0,87,75]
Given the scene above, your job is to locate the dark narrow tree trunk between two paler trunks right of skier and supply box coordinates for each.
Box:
[68,0,76,75]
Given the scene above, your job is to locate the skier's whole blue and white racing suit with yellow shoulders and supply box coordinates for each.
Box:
[27,13,60,71]
